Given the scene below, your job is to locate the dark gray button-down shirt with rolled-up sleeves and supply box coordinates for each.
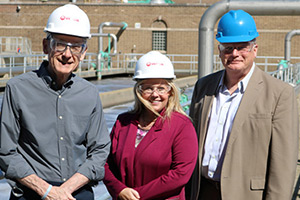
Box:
[0,61,110,188]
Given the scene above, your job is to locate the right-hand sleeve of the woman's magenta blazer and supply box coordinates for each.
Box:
[134,121,198,199]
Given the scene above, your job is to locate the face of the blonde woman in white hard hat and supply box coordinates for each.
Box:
[139,78,171,113]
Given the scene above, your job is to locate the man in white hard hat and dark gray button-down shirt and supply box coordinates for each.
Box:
[0,4,110,200]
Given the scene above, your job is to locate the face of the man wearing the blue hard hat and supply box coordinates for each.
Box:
[219,42,258,76]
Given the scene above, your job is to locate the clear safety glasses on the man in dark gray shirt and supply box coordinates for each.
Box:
[50,37,87,55]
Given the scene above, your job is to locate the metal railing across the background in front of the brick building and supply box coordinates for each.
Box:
[0,53,300,85]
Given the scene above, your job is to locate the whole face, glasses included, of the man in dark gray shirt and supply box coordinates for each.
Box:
[43,34,87,78]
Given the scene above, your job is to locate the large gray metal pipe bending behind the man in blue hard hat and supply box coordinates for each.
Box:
[198,0,300,78]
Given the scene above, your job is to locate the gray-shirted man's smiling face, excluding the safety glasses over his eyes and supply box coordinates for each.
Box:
[43,34,87,80]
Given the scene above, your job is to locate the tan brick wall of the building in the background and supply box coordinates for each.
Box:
[0,0,300,62]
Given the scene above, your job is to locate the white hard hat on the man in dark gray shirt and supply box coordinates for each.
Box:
[44,4,91,38]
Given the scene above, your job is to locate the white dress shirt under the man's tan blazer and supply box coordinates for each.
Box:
[202,63,255,181]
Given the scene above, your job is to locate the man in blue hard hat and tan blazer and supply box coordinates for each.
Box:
[186,10,299,200]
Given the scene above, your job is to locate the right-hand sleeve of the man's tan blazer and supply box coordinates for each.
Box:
[266,86,299,200]
